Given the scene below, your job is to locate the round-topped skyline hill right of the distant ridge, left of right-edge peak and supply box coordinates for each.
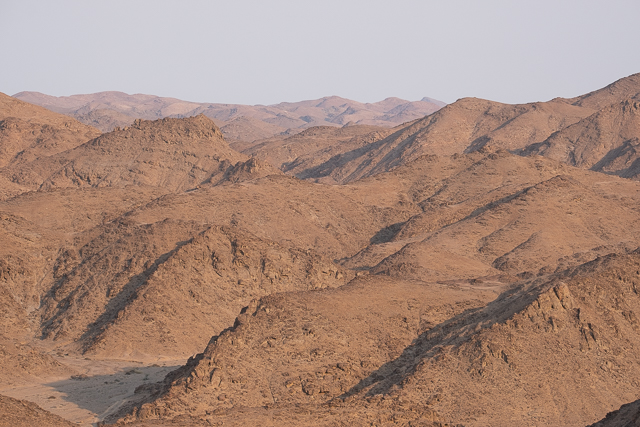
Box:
[298,98,593,183]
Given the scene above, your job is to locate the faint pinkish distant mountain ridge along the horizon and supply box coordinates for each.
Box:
[13,91,446,140]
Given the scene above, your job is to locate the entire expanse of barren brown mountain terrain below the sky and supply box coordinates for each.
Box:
[0,74,640,427]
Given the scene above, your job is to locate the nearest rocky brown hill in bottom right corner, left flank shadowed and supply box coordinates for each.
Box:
[354,252,640,426]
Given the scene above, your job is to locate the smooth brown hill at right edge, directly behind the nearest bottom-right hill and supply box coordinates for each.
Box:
[372,167,640,278]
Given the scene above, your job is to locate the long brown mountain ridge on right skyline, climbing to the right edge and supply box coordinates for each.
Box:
[286,74,640,183]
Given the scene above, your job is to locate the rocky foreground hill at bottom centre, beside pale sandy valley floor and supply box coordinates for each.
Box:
[107,277,495,419]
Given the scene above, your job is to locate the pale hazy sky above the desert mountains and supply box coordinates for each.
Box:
[0,0,640,104]
